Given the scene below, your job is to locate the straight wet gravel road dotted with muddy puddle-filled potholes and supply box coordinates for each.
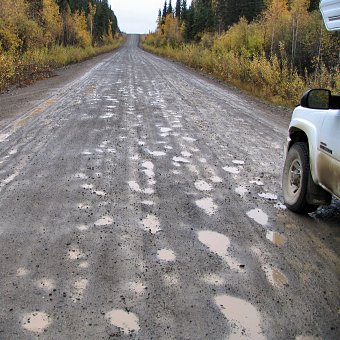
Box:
[0,36,340,340]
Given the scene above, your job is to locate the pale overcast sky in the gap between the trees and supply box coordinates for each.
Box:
[109,0,191,33]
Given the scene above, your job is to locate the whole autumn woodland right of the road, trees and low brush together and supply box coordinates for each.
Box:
[143,0,340,106]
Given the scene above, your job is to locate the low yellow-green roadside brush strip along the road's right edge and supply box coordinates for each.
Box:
[141,37,340,107]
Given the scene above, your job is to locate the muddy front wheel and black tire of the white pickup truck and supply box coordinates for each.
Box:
[282,142,318,214]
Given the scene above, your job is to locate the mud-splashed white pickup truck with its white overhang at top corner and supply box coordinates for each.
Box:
[282,0,340,213]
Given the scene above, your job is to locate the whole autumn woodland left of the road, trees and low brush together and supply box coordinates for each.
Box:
[0,0,122,91]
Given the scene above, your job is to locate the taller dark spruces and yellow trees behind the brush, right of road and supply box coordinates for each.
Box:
[157,0,340,72]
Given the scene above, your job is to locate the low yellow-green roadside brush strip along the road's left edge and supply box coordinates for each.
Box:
[0,37,124,91]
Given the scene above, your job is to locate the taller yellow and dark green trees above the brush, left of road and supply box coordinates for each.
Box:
[0,0,119,54]
